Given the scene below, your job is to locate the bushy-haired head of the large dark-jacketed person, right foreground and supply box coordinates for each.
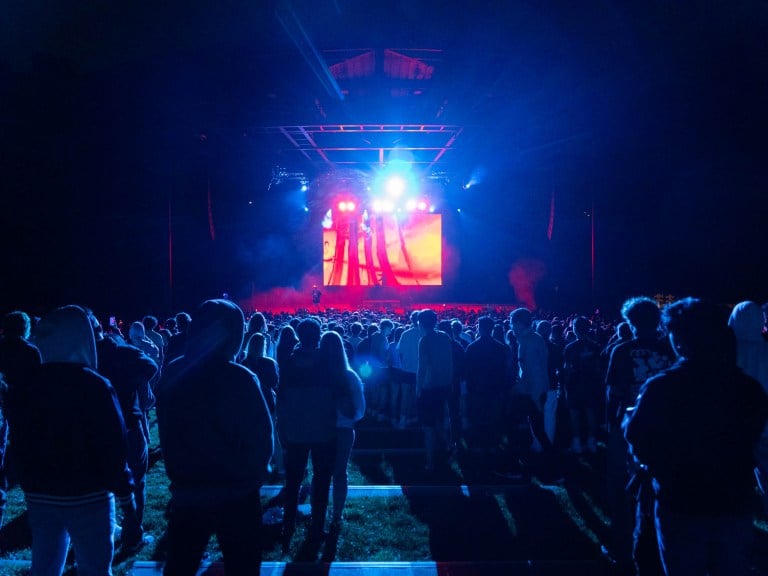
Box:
[661,298,736,363]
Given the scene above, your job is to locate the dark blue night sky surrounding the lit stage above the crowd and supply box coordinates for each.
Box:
[0,0,768,316]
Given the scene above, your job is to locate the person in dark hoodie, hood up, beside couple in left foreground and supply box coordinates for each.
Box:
[156,300,273,576]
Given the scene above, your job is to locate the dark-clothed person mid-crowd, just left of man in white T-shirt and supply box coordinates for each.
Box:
[465,316,509,451]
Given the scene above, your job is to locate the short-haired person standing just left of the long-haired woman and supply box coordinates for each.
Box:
[277,318,337,552]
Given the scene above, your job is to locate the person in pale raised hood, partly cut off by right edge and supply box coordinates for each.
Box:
[728,301,768,513]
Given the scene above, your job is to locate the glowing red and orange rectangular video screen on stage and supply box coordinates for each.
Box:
[323,212,443,286]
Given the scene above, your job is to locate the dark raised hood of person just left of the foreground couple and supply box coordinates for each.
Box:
[184,299,245,361]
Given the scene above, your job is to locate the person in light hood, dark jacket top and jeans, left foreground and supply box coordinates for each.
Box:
[7,306,140,575]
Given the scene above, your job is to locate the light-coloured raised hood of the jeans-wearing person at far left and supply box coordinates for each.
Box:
[35,306,96,370]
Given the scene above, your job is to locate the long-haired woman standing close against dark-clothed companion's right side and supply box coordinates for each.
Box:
[320,332,365,533]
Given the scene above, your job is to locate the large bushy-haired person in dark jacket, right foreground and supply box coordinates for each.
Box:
[624,298,768,576]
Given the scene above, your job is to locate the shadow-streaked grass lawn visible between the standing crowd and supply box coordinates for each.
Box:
[0,412,768,575]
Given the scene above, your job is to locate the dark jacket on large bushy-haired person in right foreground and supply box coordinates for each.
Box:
[625,360,768,516]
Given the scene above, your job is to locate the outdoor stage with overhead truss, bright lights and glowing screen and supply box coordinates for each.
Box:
[249,124,471,308]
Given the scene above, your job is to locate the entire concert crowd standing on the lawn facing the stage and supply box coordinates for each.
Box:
[0,297,768,576]
